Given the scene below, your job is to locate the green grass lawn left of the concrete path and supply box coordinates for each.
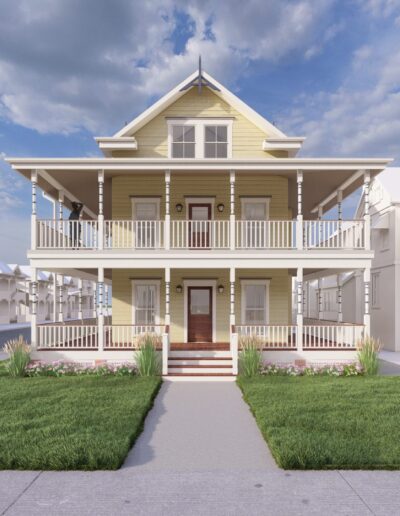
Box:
[0,360,161,470]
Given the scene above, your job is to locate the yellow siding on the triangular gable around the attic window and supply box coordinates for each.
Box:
[113,88,287,159]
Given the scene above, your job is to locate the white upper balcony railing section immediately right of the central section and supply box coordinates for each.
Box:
[236,220,296,249]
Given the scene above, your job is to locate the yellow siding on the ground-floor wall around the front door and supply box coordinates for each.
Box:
[112,269,291,342]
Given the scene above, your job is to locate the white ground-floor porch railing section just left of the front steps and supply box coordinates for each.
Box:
[104,324,164,349]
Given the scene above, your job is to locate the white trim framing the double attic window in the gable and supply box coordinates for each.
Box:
[167,118,233,159]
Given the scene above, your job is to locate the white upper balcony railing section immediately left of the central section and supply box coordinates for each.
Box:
[104,220,164,249]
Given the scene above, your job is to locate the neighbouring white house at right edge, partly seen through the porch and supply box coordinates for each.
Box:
[304,167,400,351]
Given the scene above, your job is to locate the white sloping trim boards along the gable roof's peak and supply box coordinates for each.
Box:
[114,70,286,138]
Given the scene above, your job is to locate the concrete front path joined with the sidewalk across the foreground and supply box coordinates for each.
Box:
[0,382,400,516]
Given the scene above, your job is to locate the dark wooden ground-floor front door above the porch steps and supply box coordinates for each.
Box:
[188,287,212,342]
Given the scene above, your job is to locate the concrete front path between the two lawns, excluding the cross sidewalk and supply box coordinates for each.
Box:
[124,381,277,471]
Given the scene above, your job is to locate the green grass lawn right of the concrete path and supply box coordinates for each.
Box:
[238,376,400,469]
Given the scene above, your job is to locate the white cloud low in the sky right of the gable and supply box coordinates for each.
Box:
[281,38,400,158]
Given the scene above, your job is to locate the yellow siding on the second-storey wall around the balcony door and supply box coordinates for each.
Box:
[112,172,290,220]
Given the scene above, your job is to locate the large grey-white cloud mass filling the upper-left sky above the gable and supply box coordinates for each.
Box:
[0,0,338,134]
